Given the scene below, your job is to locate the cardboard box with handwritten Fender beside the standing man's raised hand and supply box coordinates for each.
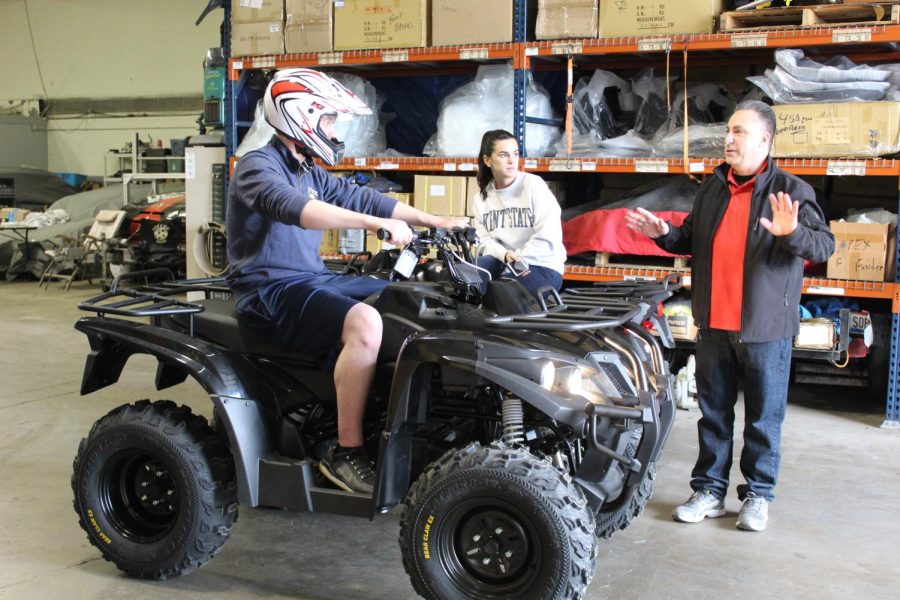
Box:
[828,221,897,281]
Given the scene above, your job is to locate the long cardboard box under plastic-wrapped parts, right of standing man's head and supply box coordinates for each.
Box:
[772,102,900,158]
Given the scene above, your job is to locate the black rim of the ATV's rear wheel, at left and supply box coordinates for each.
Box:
[99,449,179,544]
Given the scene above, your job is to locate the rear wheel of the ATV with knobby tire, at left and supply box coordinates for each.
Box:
[72,400,237,579]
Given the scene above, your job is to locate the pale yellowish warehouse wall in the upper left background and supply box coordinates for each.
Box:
[0,0,223,176]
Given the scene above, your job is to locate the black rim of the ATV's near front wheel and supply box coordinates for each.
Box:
[435,498,541,598]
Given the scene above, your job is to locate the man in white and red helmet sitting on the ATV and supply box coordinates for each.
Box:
[226,69,457,493]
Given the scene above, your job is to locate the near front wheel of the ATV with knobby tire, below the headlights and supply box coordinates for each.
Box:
[400,443,597,600]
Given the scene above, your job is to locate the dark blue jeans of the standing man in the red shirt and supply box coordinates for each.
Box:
[691,329,791,501]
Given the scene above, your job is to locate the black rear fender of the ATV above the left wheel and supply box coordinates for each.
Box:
[75,317,274,506]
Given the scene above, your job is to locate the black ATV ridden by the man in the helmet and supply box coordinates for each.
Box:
[72,229,675,599]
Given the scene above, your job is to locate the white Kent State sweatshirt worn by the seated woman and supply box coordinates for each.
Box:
[475,172,566,273]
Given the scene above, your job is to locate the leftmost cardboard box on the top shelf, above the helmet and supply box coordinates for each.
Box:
[231,0,284,56]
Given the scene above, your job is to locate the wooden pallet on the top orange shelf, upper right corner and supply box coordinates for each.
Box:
[719,3,900,33]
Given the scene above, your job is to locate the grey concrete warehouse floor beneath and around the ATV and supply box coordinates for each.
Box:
[0,281,900,600]
